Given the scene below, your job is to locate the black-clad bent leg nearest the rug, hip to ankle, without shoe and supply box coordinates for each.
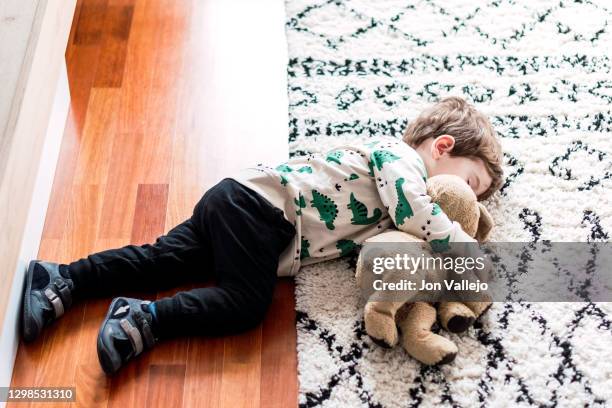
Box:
[154,180,295,337]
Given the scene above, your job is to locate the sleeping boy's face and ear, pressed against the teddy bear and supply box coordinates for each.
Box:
[416,135,493,197]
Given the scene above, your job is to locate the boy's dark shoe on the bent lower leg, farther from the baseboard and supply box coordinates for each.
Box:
[98,297,157,375]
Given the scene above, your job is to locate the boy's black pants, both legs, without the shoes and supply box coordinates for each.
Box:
[68,179,295,337]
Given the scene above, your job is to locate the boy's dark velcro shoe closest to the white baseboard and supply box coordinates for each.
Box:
[22,261,74,341]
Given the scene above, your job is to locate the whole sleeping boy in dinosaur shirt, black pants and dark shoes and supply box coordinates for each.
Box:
[23,97,502,374]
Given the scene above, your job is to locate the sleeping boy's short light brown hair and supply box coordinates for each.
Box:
[404,96,503,200]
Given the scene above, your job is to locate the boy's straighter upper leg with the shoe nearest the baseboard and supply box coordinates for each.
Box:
[22,209,212,341]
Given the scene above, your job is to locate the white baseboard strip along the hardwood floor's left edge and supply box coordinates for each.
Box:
[0,63,70,398]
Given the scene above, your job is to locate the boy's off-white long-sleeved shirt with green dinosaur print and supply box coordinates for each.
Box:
[234,137,474,276]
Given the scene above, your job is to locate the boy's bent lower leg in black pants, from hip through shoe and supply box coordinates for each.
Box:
[98,180,295,373]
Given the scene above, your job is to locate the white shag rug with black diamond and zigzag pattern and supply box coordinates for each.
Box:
[286,0,612,407]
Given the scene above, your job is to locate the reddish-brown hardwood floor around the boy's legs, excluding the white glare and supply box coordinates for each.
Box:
[8,0,297,408]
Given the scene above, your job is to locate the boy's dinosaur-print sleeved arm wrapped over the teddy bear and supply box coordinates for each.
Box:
[369,144,475,252]
